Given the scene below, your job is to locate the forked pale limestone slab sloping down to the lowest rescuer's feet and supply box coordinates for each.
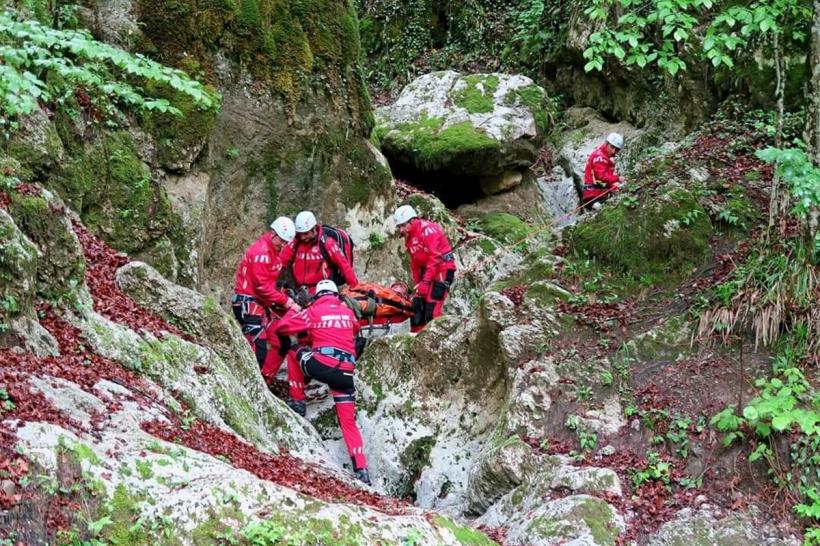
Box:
[105,262,320,454]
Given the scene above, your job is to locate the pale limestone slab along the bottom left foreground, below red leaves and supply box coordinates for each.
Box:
[11,377,489,546]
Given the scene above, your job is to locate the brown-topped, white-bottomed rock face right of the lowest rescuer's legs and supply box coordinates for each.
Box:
[357,304,507,513]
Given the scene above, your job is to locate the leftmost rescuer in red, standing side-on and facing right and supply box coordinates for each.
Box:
[231,216,299,378]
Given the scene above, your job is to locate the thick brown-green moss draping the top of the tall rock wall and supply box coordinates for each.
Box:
[136,0,360,104]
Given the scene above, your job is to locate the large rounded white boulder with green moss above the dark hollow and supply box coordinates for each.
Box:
[376,71,549,183]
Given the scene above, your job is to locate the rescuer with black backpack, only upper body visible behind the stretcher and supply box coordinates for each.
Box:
[280,210,359,295]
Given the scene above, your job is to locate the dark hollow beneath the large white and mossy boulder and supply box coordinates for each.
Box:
[388,160,486,210]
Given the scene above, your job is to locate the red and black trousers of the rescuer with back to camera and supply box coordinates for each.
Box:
[287,347,367,470]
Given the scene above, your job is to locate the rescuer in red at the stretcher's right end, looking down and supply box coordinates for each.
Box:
[393,205,456,331]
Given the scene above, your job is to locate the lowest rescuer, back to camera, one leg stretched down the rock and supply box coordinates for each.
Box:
[276,280,370,484]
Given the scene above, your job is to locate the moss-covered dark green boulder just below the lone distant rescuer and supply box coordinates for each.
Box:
[567,188,713,284]
